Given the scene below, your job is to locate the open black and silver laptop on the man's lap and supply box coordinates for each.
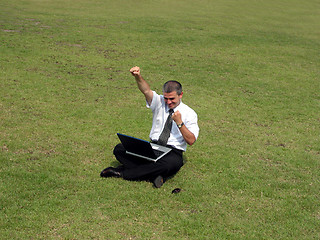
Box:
[117,133,172,162]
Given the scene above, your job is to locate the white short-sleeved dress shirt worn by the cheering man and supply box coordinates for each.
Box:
[147,91,199,151]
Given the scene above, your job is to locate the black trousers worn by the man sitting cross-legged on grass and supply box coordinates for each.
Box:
[113,143,183,181]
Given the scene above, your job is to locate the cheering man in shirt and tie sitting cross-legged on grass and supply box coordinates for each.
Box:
[100,67,199,188]
